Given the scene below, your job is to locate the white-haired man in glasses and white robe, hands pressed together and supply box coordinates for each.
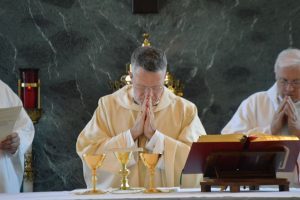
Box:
[221,49,300,184]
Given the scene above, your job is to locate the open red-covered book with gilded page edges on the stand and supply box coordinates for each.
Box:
[183,133,300,178]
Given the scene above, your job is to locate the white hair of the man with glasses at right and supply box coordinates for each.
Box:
[274,49,300,73]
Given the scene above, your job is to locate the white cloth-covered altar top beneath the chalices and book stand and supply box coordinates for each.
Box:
[0,187,300,200]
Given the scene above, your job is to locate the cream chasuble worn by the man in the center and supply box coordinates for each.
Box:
[76,85,206,188]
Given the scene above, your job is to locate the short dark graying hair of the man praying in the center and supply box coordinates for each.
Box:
[131,46,167,72]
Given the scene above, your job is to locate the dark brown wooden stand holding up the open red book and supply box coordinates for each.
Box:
[200,151,289,192]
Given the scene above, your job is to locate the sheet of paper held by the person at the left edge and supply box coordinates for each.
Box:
[0,106,22,142]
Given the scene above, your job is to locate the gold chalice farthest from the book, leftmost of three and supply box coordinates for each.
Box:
[83,154,105,194]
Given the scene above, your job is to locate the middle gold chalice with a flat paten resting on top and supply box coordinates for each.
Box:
[110,148,143,193]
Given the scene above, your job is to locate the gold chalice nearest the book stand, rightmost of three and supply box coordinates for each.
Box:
[140,152,161,193]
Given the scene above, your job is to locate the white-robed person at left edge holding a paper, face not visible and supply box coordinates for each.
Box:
[0,80,34,193]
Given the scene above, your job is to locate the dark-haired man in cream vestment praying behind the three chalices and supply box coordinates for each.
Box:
[77,47,206,188]
